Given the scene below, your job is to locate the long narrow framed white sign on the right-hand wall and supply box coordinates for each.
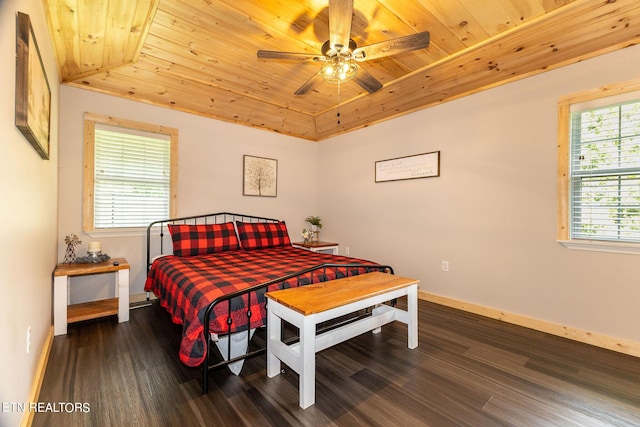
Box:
[375,151,440,182]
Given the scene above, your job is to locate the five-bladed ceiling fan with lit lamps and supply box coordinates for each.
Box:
[258,0,429,95]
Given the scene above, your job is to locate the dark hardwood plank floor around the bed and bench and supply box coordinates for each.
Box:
[33,301,640,427]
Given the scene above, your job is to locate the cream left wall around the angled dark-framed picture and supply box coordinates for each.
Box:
[0,0,58,426]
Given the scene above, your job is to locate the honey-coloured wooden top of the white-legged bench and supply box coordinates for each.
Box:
[266,272,420,316]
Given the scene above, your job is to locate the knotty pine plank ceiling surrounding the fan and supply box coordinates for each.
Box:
[45,0,640,140]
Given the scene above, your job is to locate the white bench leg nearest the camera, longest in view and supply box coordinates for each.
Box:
[299,316,316,409]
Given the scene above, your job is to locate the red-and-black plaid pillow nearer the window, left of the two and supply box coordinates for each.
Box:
[168,222,239,256]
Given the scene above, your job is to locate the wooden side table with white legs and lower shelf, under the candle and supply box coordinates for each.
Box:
[53,258,130,335]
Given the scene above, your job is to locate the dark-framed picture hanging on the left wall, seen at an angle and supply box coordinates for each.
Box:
[16,12,51,159]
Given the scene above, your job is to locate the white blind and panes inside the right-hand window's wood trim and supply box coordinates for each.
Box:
[570,100,640,242]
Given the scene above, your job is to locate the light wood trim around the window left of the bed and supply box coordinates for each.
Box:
[82,113,178,236]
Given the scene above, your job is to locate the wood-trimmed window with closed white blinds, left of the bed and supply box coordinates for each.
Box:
[83,113,178,231]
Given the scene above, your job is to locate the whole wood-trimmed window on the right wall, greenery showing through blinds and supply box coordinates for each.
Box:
[558,79,640,251]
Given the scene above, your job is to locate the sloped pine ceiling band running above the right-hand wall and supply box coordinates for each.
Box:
[316,0,640,140]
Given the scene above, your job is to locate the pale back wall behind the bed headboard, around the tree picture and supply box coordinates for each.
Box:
[58,86,318,303]
